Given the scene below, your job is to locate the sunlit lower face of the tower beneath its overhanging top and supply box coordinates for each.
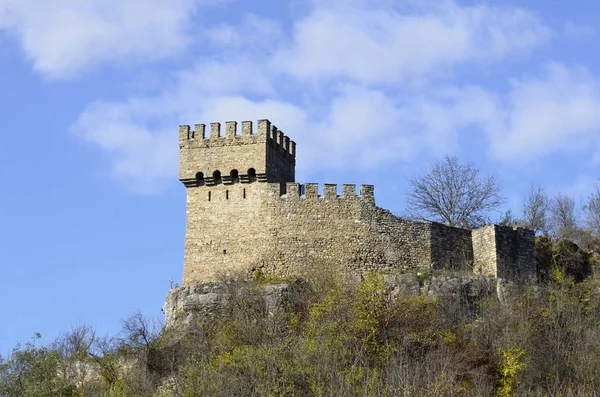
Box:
[183,183,271,285]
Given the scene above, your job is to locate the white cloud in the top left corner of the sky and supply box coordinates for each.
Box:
[0,0,223,79]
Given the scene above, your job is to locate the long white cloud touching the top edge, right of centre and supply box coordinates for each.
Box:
[273,1,550,83]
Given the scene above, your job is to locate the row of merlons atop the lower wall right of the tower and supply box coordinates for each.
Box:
[273,182,375,203]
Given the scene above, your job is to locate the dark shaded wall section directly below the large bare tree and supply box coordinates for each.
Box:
[431,222,473,270]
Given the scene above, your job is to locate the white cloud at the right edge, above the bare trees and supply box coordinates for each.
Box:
[487,63,600,163]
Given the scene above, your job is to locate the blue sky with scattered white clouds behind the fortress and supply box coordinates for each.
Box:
[0,0,600,355]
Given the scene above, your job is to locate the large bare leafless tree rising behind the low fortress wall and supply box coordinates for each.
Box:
[407,156,504,228]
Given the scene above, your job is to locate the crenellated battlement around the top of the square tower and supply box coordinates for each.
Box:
[179,119,296,159]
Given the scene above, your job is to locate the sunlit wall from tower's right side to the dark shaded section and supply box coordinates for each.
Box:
[255,183,431,277]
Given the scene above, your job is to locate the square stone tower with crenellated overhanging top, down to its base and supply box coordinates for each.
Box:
[179,120,296,284]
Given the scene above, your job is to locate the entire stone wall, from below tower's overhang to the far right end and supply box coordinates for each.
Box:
[183,182,535,285]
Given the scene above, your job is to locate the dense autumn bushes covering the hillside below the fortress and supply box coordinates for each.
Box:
[0,267,600,397]
